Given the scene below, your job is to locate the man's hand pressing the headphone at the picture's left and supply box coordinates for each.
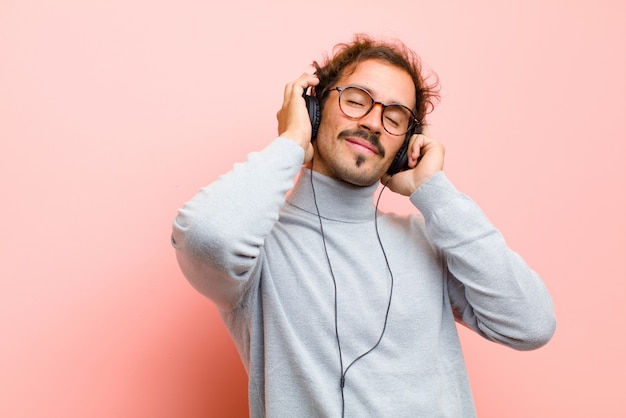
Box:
[276,73,319,164]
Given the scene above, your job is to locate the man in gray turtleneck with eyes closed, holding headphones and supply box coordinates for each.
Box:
[172,36,555,417]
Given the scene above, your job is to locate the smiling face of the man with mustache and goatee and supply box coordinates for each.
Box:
[313,60,415,186]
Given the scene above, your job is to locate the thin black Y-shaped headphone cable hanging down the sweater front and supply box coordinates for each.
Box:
[311,165,393,418]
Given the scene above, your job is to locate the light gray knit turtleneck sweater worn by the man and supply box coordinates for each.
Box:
[173,138,555,418]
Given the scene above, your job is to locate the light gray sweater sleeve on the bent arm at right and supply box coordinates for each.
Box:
[411,172,556,350]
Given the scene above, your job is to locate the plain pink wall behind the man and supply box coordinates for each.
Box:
[0,0,626,418]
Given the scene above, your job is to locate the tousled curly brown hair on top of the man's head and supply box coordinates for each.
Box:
[313,34,439,124]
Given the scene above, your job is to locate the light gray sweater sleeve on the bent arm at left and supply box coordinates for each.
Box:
[172,138,304,310]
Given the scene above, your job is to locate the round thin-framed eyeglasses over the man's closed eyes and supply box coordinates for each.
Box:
[330,86,418,136]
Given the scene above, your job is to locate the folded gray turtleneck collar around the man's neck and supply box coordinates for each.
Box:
[287,167,378,222]
